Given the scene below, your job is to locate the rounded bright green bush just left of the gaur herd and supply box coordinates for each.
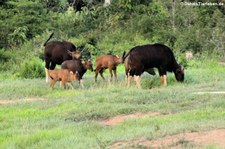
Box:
[18,58,45,78]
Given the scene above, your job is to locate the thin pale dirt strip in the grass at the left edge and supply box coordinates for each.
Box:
[0,98,47,105]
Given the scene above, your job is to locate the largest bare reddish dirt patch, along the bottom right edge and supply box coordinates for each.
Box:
[107,129,225,149]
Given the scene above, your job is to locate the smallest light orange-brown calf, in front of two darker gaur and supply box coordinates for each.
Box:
[48,69,79,89]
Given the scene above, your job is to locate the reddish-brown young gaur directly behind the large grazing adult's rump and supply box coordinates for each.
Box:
[95,54,122,81]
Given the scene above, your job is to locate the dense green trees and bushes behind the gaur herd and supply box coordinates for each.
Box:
[0,0,225,78]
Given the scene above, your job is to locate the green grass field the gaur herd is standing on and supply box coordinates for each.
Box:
[0,60,225,149]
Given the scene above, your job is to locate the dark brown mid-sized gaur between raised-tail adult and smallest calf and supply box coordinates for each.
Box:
[61,59,93,87]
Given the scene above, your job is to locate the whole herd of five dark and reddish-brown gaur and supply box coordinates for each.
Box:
[44,33,184,89]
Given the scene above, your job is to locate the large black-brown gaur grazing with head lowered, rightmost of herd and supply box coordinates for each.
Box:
[122,44,184,87]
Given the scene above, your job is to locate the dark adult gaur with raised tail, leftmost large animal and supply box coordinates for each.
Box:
[44,33,81,82]
